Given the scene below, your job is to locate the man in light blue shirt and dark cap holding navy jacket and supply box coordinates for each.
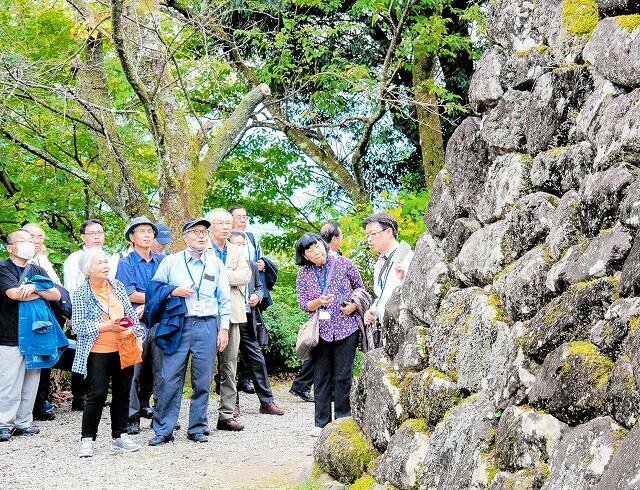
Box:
[148,219,231,446]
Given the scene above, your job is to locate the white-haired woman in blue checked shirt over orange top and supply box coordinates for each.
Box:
[72,248,144,458]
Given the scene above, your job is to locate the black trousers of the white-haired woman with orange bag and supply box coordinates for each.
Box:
[82,352,133,440]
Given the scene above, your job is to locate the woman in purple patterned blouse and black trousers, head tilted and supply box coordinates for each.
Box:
[296,233,364,436]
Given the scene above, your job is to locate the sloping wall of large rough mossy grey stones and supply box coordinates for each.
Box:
[316,0,640,489]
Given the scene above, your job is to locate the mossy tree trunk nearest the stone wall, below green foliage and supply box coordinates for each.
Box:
[413,54,444,187]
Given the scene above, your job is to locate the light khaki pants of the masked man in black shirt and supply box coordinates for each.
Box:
[0,345,40,429]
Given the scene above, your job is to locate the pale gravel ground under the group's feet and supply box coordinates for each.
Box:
[0,385,315,489]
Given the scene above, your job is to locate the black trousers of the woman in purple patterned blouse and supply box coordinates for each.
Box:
[313,330,360,427]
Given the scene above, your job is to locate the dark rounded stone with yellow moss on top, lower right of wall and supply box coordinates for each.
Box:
[529,341,613,425]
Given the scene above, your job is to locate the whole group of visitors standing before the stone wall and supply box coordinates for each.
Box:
[0,206,412,457]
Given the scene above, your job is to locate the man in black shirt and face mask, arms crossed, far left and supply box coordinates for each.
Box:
[0,230,60,441]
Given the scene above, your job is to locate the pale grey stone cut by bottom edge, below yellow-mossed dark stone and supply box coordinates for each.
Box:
[542,417,625,490]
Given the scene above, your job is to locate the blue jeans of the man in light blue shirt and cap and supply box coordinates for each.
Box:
[153,317,218,437]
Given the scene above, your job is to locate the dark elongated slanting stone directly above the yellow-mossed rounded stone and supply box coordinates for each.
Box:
[523,277,618,361]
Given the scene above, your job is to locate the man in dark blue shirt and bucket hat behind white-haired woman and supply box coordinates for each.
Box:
[116,216,164,434]
